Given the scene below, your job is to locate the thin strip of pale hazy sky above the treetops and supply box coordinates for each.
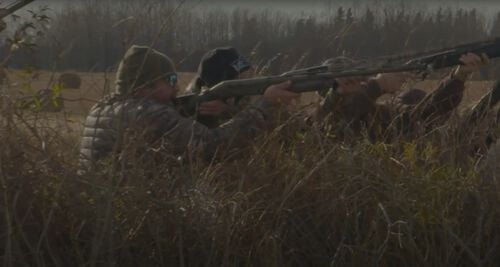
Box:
[7,0,500,21]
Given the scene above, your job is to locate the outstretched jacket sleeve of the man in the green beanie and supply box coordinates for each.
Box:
[139,99,272,157]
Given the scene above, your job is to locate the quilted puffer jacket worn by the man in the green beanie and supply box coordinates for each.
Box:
[80,96,272,170]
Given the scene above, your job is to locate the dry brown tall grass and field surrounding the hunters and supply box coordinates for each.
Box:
[0,1,500,266]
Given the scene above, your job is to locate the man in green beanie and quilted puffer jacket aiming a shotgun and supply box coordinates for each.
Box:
[80,46,298,171]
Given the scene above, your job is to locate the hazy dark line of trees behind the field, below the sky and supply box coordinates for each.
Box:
[4,1,500,72]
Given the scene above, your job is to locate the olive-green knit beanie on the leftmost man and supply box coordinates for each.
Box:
[115,45,175,95]
